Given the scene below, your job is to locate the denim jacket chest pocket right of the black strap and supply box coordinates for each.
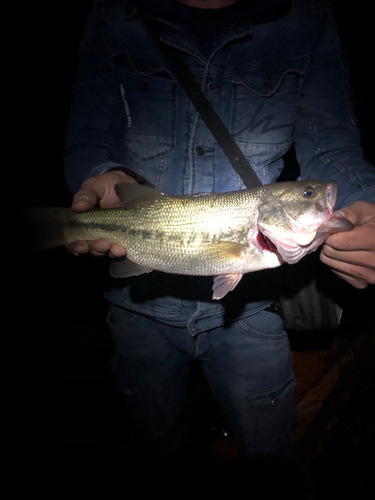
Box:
[230,68,303,167]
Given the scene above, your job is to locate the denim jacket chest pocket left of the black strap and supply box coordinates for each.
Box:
[113,52,177,161]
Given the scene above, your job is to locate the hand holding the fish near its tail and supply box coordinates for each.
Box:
[66,170,137,257]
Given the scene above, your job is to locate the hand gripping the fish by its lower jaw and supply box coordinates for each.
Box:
[320,201,375,288]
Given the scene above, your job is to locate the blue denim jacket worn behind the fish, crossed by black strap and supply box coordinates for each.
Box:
[66,0,375,334]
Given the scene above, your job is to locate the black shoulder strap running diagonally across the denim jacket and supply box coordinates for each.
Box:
[159,43,262,188]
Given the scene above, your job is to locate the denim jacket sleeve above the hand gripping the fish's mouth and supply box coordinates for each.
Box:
[293,14,375,209]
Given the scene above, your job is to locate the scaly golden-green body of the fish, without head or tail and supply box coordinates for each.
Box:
[65,186,280,276]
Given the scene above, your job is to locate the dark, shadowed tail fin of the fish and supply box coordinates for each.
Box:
[8,208,72,252]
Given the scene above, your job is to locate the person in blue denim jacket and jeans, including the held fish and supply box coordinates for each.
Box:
[61,0,375,480]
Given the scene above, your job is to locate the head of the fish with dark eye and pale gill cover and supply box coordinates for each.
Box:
[256,180,353,264]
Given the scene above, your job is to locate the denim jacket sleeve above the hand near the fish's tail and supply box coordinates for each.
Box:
[65,0,127,192]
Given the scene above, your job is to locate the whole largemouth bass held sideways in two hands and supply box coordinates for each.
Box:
[19,179,353,300]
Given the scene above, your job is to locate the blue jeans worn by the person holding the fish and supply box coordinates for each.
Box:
[108,305,295,458]
